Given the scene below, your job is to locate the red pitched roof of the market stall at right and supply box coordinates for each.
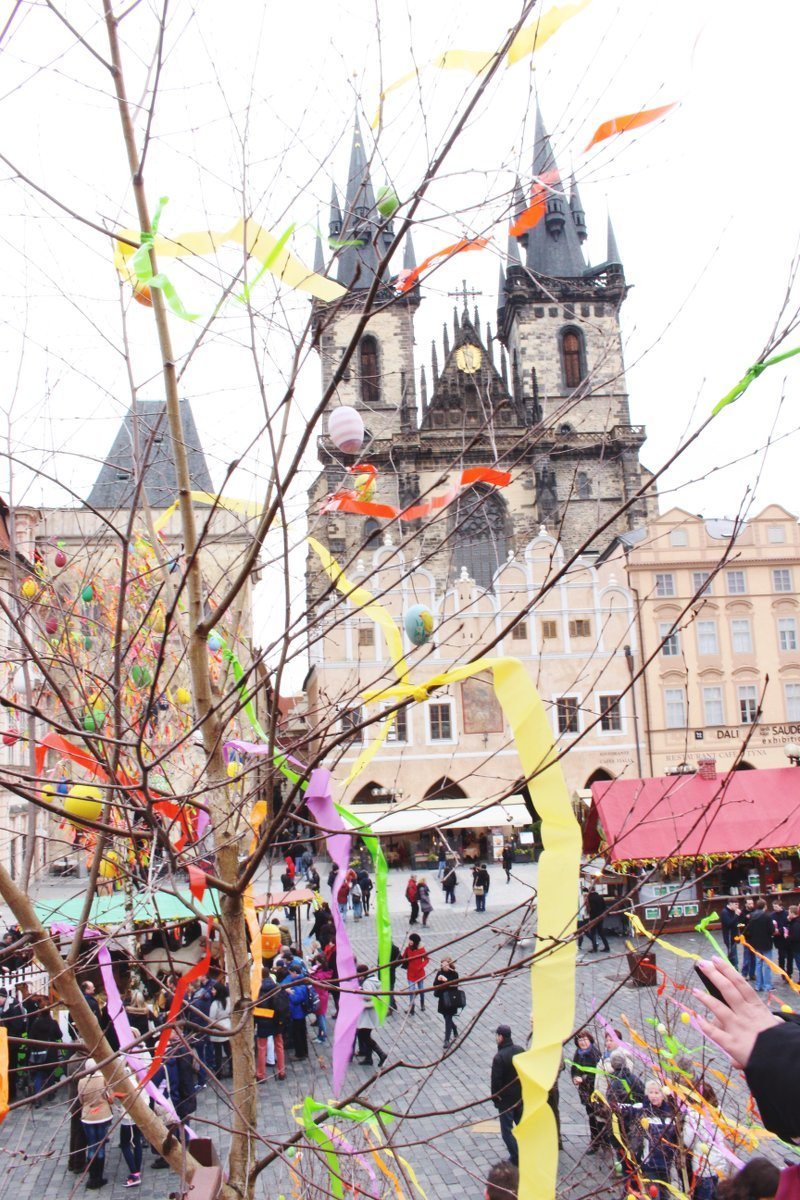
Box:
[584,767,800,863]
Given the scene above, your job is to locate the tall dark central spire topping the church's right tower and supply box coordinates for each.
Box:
[527,110,585,280]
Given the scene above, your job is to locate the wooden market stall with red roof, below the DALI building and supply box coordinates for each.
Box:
[584,767,800,931]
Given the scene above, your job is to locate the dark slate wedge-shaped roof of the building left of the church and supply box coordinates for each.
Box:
[88,400,213,509]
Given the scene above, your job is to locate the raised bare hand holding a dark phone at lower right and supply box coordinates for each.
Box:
[692,955,782,1070]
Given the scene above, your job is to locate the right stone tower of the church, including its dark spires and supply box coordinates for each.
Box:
[498,113,646,551]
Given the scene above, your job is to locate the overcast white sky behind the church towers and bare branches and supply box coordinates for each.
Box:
[0,0,800,676]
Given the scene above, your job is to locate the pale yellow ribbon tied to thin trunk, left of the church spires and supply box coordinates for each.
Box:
[114,221,347,301]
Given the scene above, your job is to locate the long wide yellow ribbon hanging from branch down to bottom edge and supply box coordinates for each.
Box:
[308,538,581,1200]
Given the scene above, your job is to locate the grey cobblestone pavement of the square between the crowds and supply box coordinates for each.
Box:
[0,865,753,1200]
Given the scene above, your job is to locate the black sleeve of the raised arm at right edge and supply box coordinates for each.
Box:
[745,1013,800,1141]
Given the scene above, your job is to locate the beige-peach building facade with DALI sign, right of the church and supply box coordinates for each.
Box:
[607,505,800,775]
